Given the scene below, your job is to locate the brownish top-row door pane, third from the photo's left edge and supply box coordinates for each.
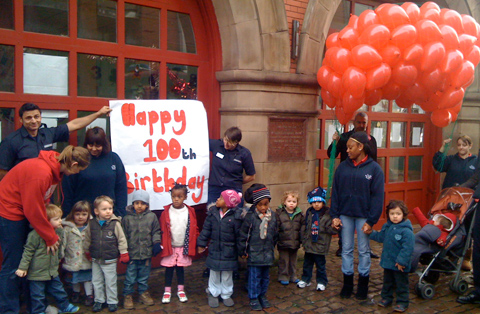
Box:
[78,0,117,42]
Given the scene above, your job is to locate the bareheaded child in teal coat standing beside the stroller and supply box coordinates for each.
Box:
[367,200,415,312]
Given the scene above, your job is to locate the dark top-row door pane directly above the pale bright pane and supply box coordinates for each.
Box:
[23,0,68,36]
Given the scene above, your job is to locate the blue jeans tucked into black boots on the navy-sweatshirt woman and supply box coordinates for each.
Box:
[340,215,371,276]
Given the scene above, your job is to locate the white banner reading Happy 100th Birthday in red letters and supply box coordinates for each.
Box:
[110,100,210,210]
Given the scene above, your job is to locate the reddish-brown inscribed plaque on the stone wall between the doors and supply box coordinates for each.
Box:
[268,118,306,161]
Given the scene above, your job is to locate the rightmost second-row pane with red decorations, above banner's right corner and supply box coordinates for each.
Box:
[167,63,198,99]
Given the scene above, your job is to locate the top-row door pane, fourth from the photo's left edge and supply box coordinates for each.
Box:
[125,3,160,48]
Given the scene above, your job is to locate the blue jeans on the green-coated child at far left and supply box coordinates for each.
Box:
[29,276,70,314]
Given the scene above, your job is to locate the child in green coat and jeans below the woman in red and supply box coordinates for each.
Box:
[16,204,79,314]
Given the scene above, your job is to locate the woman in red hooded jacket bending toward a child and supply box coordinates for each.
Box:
[0,145,90,313]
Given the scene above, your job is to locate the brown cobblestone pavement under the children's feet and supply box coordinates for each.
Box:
[59,239,480,314]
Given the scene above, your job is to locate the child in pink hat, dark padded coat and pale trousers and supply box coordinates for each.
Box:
[197,190,242,308]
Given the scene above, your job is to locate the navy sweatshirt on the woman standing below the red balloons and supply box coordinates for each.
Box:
[330,157,385,226]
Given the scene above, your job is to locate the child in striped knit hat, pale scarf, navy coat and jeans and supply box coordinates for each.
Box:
[238,186,278,311]
